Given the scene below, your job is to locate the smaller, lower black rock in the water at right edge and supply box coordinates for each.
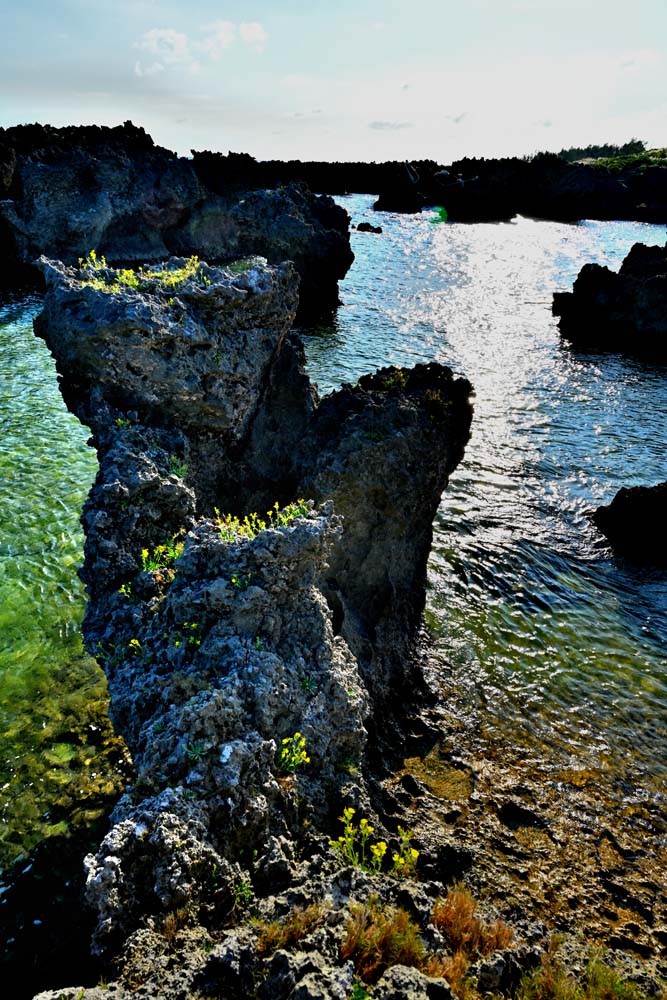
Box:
[593,482,667,566]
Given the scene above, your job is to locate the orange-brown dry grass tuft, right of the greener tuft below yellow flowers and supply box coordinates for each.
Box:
[431,883,513,958]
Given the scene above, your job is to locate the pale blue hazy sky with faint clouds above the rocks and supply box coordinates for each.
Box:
[0,0,667,163]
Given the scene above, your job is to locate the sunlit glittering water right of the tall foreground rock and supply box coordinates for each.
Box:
[306,196,667,789]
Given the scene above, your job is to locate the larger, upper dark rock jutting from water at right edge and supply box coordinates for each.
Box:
[553,243,667,364]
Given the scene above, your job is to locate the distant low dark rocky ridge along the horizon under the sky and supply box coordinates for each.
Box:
[194,152,667,222]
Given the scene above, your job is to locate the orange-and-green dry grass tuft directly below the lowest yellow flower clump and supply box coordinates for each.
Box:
[341,899,426,983]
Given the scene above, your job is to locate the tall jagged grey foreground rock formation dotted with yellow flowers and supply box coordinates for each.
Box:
[36,259,471,997]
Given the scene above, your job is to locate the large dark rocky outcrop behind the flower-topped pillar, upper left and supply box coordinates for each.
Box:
[0,122,354,315]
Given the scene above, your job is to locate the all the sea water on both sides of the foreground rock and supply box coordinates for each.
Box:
[0,201,667,865]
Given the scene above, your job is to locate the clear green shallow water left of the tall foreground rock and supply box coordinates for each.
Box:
[0,296,121,867]
